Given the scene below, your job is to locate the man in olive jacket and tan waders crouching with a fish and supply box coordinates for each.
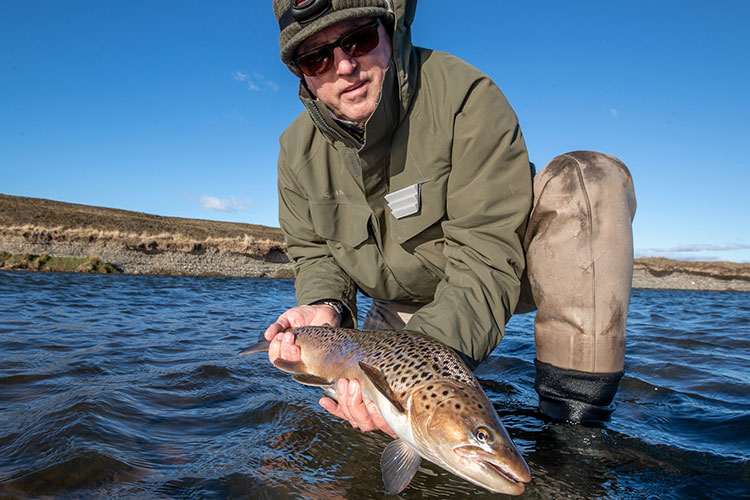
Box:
[265,0,635,434]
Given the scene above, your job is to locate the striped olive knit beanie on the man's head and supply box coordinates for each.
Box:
[273,0,393,77]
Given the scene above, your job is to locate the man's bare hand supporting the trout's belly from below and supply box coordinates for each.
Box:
[319,378,398,438]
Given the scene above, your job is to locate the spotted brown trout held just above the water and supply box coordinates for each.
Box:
[240,326,531,495]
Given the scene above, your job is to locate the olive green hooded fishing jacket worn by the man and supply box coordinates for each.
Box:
[278,0,531,363]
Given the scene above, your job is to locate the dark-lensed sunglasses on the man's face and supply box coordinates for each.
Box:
[292,19,380,76]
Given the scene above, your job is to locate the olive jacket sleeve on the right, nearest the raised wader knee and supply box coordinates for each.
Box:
[406,77,532,366]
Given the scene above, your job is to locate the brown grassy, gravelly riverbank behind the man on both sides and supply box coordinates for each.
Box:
[0,194,750,291]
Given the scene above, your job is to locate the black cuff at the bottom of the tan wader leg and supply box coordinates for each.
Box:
[534,359,625,425]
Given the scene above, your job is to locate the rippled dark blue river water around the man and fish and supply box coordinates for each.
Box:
[0,272,750,499]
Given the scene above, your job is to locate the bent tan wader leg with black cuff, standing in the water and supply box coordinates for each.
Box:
[524,151,636,423]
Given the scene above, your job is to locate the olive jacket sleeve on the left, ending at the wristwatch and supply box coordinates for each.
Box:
[278,141,357,327]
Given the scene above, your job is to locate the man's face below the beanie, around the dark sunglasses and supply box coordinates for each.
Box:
[297,18,392,122]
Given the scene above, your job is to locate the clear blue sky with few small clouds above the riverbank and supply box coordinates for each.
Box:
[0,0,750,262]
